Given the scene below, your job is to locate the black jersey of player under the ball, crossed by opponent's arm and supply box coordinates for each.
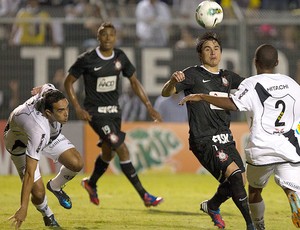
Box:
[176,66,244,140]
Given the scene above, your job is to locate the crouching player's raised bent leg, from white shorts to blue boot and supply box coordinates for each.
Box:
[44,134,83,209]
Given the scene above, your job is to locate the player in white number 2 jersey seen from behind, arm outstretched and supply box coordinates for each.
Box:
[180,44,300,230]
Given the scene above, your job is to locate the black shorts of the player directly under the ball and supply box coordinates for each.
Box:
[190,140,245,183]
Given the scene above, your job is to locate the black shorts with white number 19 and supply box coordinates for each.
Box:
[90,114,126,149]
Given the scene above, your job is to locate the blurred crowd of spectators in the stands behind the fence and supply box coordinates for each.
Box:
[0,0,300,48]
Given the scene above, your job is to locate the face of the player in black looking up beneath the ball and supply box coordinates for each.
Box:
[200,40,221,69]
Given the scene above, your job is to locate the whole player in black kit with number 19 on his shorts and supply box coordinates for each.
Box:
[64,23,163,207]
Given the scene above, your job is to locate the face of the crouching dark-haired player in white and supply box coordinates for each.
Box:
[49,98,69,124]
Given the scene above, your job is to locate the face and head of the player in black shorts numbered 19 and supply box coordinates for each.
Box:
[98,27,116,51]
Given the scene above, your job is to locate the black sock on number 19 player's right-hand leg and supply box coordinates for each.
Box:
[120,161,146,199]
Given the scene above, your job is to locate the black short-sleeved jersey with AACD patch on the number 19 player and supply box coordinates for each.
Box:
[69,47,135,111]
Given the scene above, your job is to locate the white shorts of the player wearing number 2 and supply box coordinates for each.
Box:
[246,163,300,192]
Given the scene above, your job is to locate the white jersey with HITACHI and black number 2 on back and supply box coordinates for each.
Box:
[231,74,300,165]
